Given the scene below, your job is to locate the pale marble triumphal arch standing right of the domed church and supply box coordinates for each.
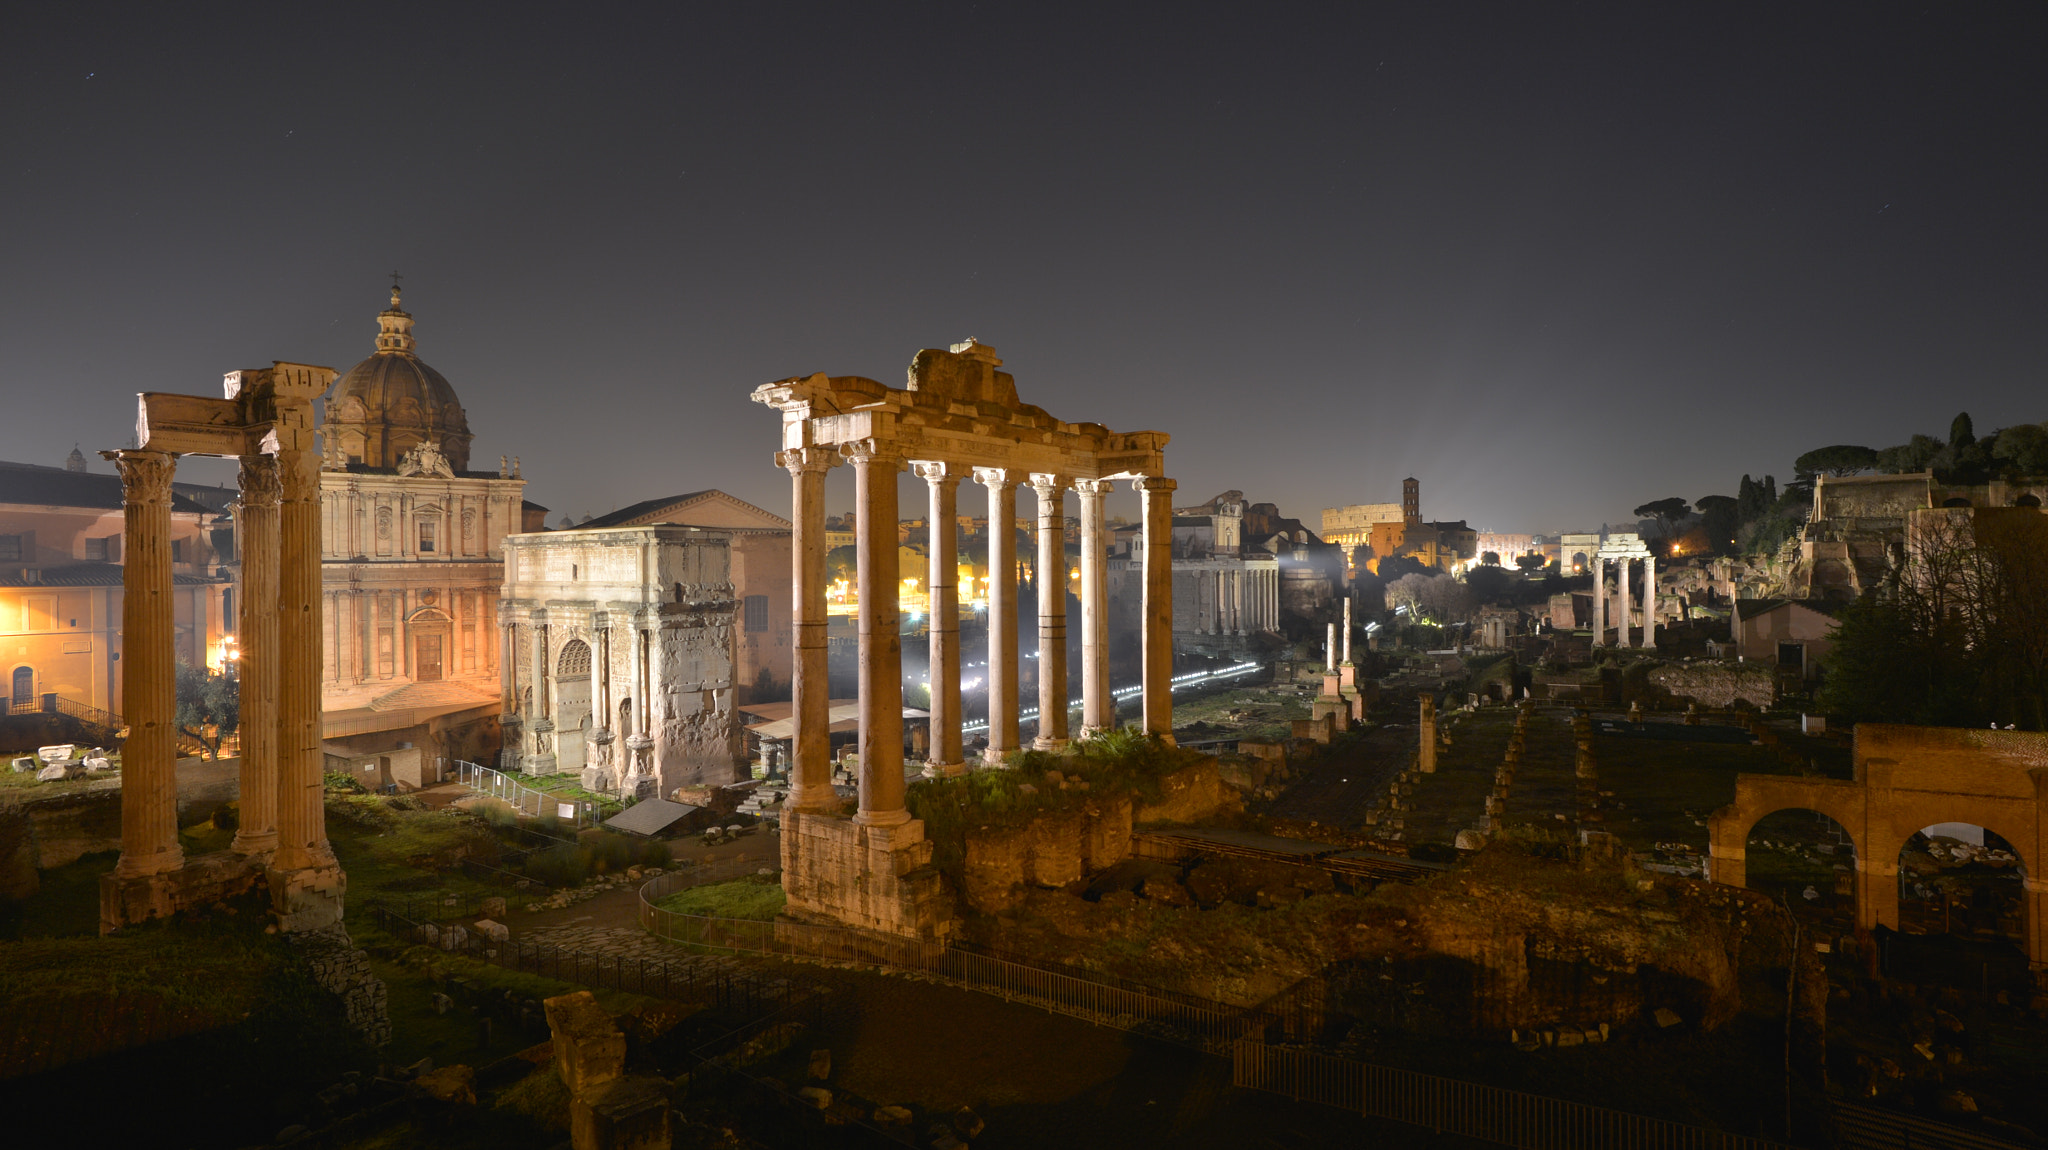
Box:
[500,524,743,796]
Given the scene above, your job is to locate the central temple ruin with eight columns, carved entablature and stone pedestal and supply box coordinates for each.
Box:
[754,340,1174,937]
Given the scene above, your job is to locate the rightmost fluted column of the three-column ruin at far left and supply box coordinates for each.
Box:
[274,450,334,870]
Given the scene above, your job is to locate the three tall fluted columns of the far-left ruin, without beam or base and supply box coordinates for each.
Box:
[102,450,334,878]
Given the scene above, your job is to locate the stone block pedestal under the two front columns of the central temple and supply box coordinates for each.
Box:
[782,810,954,939]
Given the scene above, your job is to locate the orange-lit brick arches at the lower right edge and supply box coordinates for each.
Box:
[1708,722,2048,970]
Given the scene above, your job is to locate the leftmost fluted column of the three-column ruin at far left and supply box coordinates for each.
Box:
[104,450,184,878]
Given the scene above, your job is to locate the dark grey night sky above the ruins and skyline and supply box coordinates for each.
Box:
[0,2,2048,532]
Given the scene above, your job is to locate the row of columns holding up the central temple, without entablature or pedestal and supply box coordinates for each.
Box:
[776,440,1176,827]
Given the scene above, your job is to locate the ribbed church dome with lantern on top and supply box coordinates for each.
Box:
[326,286,471,471]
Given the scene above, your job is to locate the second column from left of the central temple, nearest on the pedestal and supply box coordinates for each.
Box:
[846,440,909,827]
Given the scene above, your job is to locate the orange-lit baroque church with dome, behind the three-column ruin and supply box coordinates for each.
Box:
[319,286,545,773]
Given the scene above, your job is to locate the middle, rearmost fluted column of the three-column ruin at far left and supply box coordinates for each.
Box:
[233,454,281,855]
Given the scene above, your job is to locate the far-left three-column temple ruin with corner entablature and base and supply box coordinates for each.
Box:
[100,362,346,933]
